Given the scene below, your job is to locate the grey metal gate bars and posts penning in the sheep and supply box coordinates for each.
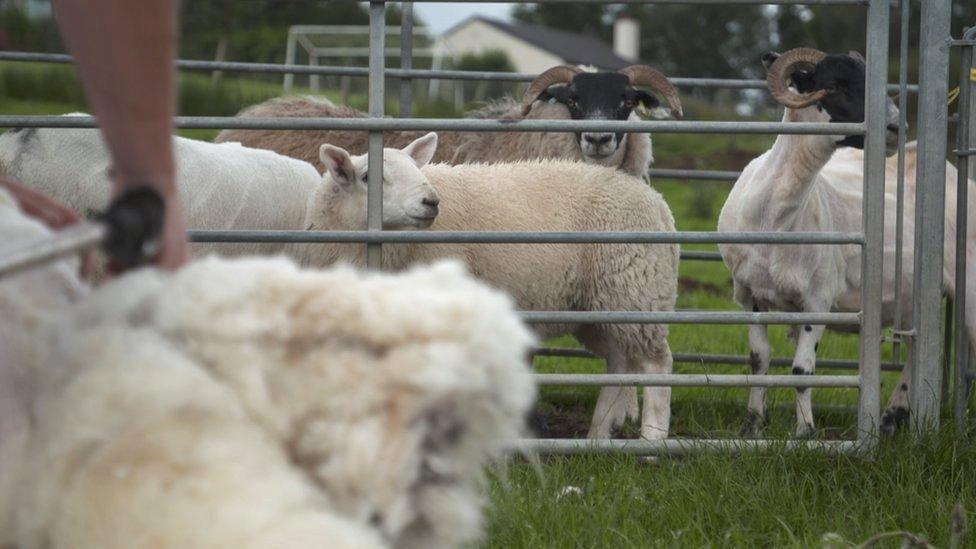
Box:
[0,0,976,455]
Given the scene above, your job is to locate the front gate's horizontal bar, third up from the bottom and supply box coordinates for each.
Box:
[519,311,861,326]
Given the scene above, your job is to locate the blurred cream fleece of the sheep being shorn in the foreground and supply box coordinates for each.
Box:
[0,187,534,549]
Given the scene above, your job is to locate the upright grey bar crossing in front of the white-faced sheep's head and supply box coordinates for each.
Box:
[366,2,386,269]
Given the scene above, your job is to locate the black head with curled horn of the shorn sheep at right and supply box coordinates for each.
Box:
[762,48,899,155]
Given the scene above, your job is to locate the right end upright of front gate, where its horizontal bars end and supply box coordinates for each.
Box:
[857,0,890,448]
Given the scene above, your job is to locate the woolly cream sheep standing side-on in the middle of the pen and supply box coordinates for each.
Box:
[297,141,678,439]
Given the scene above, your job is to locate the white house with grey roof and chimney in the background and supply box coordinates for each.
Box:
[435,16,640,73]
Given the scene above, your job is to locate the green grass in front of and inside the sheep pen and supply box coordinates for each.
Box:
[0,92,976,548]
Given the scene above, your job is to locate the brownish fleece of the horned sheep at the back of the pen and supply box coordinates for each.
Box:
[214,96,654,177]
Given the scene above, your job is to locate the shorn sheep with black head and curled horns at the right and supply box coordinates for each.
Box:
[718,48,976,437]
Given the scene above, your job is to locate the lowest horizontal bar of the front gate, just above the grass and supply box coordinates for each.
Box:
[507,438,860,456]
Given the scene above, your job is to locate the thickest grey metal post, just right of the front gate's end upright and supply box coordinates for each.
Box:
[909,0,952,433]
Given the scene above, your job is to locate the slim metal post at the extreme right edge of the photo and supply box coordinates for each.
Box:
[952,28,976,435]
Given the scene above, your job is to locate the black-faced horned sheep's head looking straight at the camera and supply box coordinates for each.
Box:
[521,65,682,165]
